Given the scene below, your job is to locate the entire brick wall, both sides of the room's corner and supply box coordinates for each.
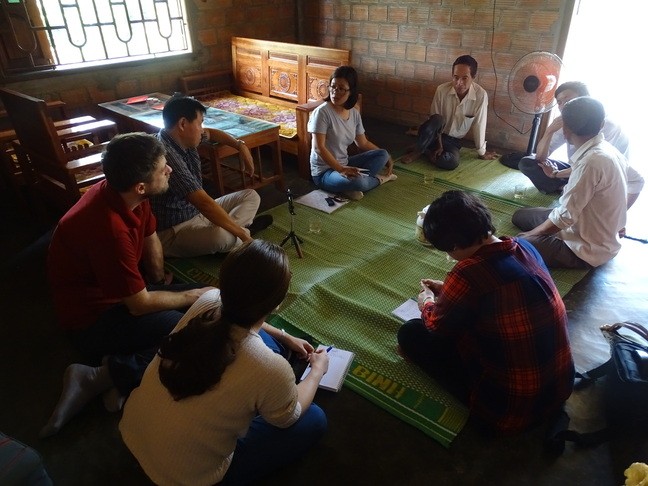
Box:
[2,0,573,150]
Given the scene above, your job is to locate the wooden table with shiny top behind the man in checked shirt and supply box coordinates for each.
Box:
[99,93,286,194]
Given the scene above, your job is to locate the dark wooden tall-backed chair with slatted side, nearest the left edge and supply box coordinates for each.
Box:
[0,88,117,211]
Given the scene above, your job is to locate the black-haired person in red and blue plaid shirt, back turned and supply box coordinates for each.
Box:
[398,191,574,433]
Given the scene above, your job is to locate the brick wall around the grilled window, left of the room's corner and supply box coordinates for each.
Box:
[1,0,296,120]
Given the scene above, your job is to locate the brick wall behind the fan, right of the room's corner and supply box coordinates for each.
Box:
[302,0,571,150]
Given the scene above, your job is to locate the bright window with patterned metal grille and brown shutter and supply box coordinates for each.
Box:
[0,0,191,74]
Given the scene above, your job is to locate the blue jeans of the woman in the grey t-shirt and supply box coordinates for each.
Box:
[313,149,389,192]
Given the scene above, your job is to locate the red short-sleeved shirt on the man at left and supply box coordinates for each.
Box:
[48,181,156,329]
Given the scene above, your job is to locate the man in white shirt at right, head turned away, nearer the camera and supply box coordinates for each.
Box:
[513,96,628,268]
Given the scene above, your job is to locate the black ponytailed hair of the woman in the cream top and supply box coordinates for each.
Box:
[158,240,291,401]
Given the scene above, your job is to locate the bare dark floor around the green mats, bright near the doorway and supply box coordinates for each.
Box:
[0,120,648,486]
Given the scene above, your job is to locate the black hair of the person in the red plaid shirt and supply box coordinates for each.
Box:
[423,191,495,252]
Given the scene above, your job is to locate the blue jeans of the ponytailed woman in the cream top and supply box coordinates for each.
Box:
[220,330,327,485]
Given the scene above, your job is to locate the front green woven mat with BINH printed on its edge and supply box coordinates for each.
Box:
[167,166,586,446]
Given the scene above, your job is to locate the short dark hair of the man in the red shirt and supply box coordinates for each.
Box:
[101,132,166,192]
